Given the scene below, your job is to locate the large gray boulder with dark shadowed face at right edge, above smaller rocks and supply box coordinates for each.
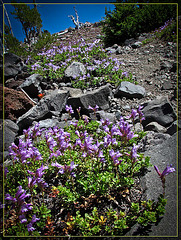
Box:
[142,96,176,126]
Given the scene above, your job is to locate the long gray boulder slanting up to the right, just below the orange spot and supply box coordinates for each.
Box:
[17,90,69,131]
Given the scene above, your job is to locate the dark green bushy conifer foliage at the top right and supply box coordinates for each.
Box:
[103,1,176,45]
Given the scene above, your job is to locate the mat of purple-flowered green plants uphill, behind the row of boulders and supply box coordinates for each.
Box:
[29,38,133,89]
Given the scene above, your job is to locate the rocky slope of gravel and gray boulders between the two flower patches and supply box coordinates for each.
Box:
[1,20,181,235]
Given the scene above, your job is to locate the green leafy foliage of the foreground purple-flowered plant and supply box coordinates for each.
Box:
[5,112,169,236]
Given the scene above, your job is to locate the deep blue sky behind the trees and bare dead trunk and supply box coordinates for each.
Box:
[3,0,114,41]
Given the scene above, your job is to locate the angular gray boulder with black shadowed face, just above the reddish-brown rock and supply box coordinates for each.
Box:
[19,74,43,98]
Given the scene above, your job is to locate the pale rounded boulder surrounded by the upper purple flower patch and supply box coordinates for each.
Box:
[65,62,86,78]
